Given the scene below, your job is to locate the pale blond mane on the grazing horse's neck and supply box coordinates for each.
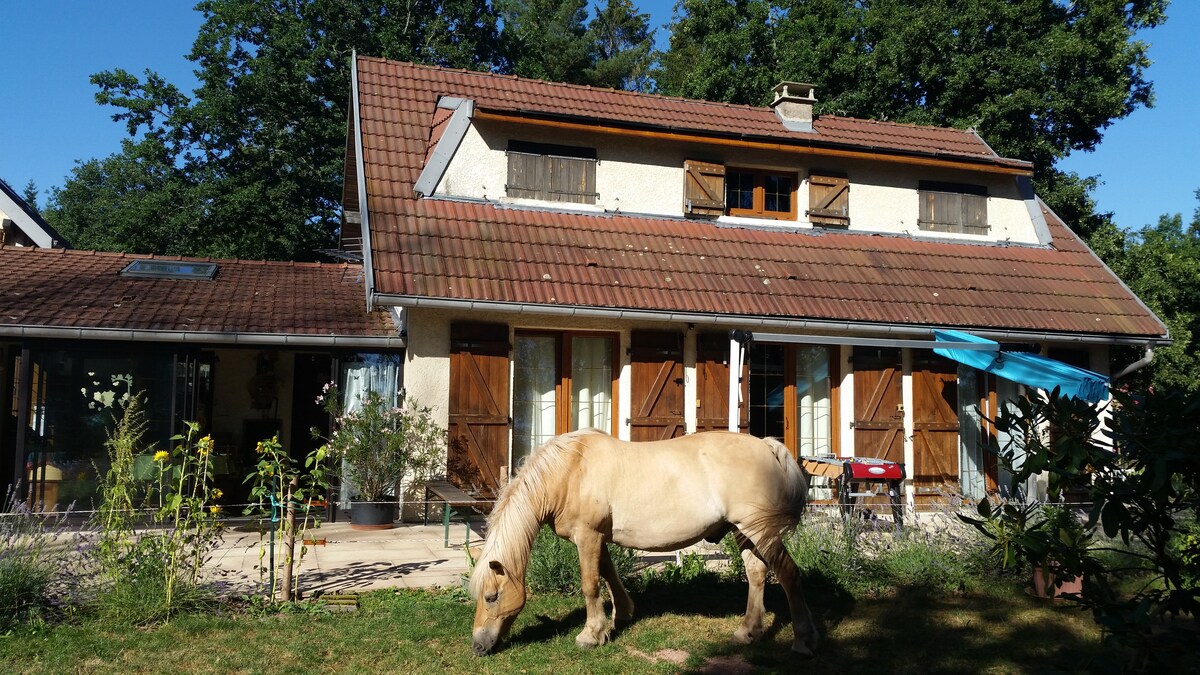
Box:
[470,429,604,597]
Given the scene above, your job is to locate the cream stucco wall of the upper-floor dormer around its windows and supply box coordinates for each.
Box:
[436,123,1038,243]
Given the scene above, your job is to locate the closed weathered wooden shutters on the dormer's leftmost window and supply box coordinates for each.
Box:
[504,141,596,204]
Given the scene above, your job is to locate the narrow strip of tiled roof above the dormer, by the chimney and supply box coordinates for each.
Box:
[359,56,1028,167]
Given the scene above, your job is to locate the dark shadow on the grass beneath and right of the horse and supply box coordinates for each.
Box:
[511,574,1104,675]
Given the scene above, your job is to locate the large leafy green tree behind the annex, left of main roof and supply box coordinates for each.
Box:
[47,0,497,259]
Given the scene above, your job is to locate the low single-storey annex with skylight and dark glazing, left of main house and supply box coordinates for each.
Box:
[0,239,404,515]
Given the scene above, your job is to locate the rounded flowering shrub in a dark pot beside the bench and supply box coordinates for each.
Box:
[314,384,446,530]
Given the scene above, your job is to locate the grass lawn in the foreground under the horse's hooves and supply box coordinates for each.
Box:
[0,580,1115,675]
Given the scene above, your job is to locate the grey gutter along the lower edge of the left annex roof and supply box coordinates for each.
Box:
[0,325,406,350]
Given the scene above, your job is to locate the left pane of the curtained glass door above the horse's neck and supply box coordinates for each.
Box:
[510,335,558,471]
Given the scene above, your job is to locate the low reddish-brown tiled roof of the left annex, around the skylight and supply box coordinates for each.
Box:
[0,246,396,338]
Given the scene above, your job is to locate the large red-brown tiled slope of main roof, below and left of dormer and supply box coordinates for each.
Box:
[359,60,1165,338]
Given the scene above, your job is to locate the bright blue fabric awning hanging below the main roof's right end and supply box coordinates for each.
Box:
[934,330,1109,404]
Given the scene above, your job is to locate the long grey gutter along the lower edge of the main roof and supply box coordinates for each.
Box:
[374,293,1170,345]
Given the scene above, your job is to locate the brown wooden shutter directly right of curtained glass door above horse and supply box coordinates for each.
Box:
[629,330,684,441]
